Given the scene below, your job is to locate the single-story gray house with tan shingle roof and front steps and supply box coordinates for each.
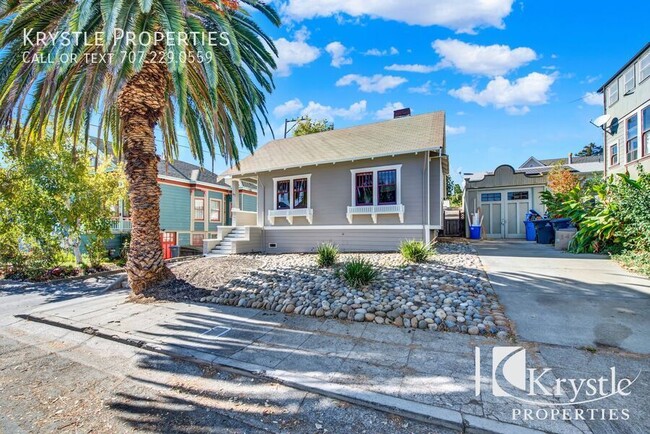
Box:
[211,111,449,254]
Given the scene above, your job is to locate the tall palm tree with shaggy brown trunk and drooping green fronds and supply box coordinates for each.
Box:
[0,0,280,293]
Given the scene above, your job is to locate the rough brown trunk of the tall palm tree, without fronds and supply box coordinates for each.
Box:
[118,46,171,294]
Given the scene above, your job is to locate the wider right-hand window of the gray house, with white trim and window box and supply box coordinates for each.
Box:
[347,165,404,224]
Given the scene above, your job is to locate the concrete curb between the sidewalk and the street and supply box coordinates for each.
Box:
[16,314,543,434]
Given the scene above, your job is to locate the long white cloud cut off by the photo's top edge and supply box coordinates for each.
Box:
[280,0,514,33]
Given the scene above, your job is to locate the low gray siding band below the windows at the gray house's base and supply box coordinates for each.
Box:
[263,227,424,253]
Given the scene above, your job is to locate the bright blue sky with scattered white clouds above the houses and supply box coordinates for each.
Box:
[171,0,650,182]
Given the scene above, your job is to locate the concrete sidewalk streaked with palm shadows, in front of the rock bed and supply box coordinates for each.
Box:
[20,291,604,433]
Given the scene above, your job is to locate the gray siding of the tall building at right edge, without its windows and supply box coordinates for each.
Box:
[605,45,650,176]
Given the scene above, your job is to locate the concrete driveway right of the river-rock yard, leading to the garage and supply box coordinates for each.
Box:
[474,240,650,354]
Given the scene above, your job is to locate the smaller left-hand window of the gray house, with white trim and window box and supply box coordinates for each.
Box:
[268,174,314,225]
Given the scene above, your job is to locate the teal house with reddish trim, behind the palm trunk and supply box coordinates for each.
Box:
[108,160,257,259]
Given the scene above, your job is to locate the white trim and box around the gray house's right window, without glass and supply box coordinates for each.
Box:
[347,164,404,224]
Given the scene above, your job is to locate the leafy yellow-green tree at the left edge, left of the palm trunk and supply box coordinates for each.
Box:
[0,138,126,266]
